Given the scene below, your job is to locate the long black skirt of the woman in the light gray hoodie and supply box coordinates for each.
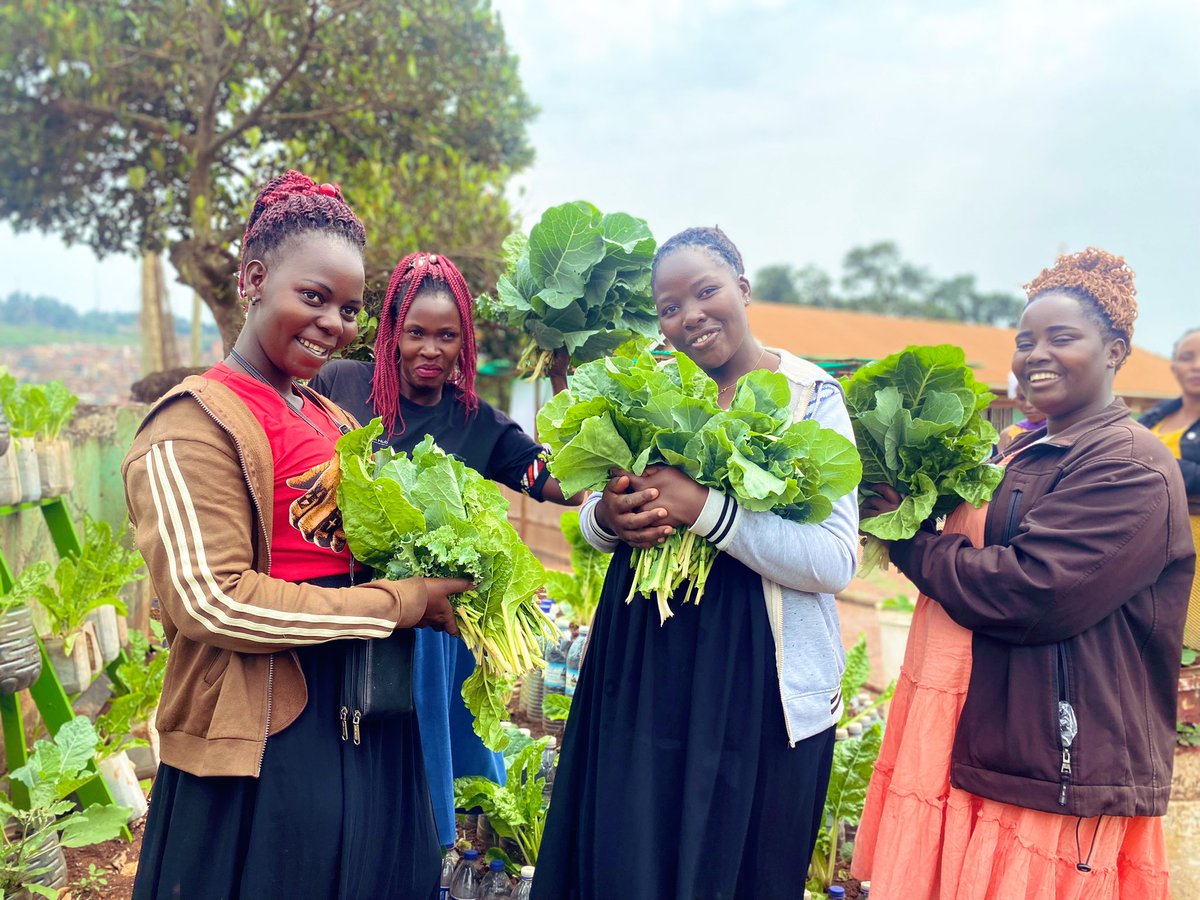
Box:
[533,546,833,900]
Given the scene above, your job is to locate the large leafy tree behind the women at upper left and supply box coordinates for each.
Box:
[0,0,534,344]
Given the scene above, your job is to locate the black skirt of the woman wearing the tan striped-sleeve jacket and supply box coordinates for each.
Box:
[133,578,440,900]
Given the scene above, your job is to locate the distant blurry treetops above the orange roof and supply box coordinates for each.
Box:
[754,241,1025,325]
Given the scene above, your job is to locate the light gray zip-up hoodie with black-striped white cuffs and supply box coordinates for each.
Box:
[580,348,858,746]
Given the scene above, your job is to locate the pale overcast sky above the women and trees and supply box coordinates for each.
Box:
[0,0,1200,353]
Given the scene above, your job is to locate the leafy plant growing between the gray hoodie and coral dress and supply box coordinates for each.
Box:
[808,636,895,890]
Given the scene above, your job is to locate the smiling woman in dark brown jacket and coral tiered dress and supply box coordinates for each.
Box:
[854,250,1195,900]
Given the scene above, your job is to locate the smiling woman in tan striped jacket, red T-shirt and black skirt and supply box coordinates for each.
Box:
[122,172,469,900]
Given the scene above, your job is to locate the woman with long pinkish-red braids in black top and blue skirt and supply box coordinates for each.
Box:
[310,253,582,845]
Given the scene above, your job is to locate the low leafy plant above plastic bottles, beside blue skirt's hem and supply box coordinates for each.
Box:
[454,738,548,865]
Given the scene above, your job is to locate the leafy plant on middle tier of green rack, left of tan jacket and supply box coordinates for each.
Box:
[37,517,145,654]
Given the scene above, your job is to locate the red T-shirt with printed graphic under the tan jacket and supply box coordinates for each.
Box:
[204,362,352,581]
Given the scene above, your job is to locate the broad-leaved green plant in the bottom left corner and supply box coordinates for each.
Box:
[0,715,130,898]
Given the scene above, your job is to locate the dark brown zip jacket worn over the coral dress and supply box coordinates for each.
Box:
[892,401,1195,816]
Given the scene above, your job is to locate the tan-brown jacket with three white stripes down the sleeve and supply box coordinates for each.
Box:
[121,376,427,775]
